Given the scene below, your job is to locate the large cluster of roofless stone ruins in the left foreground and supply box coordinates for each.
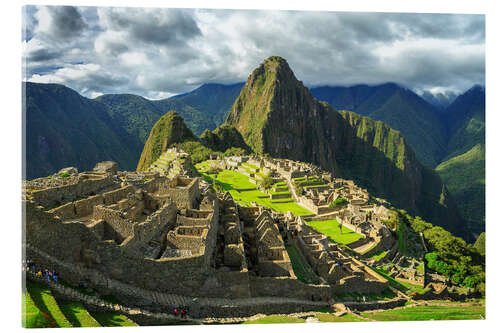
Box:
[23,158,394,314]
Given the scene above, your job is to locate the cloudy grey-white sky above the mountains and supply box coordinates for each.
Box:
[22,6,485,99]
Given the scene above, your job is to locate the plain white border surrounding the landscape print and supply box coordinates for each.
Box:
[0,0,500,333]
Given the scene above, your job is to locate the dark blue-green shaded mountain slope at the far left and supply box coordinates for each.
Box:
[23,82,141,179]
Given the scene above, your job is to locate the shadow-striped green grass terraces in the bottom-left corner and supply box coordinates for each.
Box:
[22,281,137,328]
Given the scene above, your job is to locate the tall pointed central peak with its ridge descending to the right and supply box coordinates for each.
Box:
[226,57,466,236]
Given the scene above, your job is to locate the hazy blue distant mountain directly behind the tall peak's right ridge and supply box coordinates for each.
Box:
[311,83,447,167]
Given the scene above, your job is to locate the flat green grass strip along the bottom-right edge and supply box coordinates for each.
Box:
[361,305,485,321]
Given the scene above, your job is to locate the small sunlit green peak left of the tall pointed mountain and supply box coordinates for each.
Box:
[137,111,197,171]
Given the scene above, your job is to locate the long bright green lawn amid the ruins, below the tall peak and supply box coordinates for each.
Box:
[195,161,312,216]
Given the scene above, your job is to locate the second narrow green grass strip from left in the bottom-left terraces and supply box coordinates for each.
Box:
[26,282,71,327]
